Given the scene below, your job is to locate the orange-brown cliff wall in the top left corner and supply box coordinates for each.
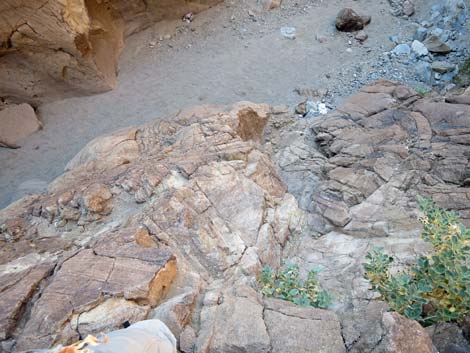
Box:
[0,0,218,103]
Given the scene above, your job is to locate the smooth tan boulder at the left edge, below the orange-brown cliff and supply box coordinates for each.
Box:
[0,103,41,148]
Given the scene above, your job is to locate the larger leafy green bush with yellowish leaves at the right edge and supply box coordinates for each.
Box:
[364,198,470,326]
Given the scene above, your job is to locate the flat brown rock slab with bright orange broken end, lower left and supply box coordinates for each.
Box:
[16,247,175,350]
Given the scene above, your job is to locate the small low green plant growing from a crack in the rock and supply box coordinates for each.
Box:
[260,265,332,309]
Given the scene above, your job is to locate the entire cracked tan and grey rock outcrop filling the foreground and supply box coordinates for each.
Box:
[0,81,470,352]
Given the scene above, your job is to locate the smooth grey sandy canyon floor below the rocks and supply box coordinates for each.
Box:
[0,0,458,207]
